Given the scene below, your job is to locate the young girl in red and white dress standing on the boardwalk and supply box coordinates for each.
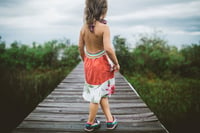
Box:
[79,0,120,132]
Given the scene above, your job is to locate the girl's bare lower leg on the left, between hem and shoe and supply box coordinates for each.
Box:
[88,103,99,123]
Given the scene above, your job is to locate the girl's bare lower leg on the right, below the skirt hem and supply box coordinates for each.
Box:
[100,97,113,121]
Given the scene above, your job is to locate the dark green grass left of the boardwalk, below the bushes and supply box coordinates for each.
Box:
[0,66,78,132]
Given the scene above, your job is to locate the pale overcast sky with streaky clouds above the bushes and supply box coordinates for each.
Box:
[0,0,200,47]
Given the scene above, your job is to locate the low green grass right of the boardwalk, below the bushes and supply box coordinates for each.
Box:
[126,74,200,133]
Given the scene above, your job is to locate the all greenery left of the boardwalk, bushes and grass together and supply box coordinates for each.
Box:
[0,40,80,132]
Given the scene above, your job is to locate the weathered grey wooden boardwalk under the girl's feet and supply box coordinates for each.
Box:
[13,63,168,133]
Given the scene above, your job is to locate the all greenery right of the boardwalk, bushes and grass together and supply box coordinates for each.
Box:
[113,36,200,132]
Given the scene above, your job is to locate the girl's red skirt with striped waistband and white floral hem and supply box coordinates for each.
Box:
[83,51,115,103]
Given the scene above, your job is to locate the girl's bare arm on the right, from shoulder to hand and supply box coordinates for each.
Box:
[103,25,120,71]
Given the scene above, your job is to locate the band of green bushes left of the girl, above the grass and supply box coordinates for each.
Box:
[0,40,79,70]
